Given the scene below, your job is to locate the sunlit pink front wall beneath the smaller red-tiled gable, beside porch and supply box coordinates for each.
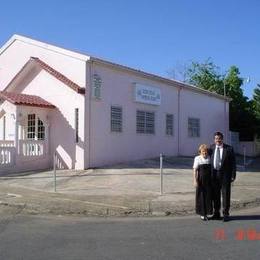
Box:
[22,71,84,169]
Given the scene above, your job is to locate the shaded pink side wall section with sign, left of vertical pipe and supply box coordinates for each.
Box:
[86,64,178,167]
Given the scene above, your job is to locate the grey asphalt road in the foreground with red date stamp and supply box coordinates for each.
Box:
[0,207,260,260]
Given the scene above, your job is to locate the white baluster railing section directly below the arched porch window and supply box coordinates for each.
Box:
[19,140,45,157]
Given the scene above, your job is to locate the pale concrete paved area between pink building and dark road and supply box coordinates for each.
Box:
[0,157,260,217]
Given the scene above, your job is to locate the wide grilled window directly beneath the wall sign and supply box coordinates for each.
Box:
[136,110,155,134]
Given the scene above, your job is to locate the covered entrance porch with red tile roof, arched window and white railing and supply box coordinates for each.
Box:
[0,92,55,172]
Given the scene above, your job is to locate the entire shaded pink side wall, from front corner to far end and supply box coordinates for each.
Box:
[86,63,228,167]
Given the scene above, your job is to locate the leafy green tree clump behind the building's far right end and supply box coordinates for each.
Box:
[178,58,260,141]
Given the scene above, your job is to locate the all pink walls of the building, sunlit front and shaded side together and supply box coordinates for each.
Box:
[0,35,228,169]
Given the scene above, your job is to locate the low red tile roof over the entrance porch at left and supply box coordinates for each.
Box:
[0,91,55,108]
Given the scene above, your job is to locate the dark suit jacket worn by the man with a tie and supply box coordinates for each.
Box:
[209,144,236,183]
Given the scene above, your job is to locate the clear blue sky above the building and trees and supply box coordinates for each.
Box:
[0,0,260,98]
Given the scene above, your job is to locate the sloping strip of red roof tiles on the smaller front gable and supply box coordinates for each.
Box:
[30,57,85,94]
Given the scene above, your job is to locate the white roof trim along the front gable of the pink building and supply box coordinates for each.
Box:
[0,34,90,61]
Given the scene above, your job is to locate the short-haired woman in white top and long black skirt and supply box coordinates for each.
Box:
[193,144,212,220]
